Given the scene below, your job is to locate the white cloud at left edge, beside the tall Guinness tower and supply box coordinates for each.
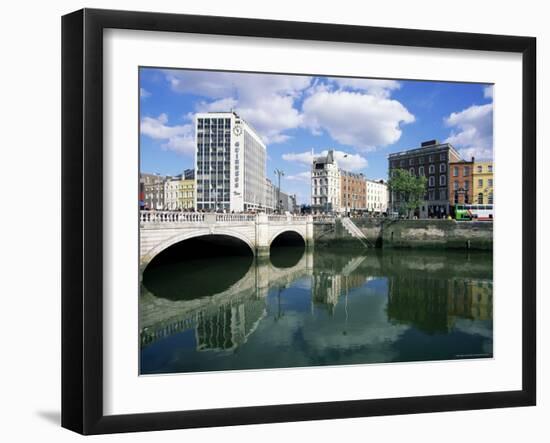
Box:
[140,113,195,155]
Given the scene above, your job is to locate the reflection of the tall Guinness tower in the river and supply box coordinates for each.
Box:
[195,299,266,351]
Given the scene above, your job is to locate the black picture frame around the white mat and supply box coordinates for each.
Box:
[62,9,536,434]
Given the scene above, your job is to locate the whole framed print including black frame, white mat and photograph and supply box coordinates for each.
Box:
[62,9,536,434]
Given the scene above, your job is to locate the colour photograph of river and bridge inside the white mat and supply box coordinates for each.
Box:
[136,66,496,375]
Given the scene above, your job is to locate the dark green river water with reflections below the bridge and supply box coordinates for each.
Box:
[139,247,493,374]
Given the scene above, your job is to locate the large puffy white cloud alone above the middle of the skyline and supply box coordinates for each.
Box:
[302,88,414,151]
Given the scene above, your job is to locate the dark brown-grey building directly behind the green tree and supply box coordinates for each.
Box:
[388,140,461,218]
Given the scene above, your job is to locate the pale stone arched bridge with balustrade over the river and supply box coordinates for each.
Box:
[139,211,313,271]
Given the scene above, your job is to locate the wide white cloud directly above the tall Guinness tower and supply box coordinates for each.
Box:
[165,70,311,143]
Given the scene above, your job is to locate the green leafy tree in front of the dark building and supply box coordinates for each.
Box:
[388,169,427,216]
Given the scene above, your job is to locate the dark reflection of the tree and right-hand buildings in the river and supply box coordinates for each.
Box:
[387,275,493,333]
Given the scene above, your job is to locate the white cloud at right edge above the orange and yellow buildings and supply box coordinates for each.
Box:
[444,103,493,159]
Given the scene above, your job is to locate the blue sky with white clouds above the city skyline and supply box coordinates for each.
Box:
[139,68,493,203]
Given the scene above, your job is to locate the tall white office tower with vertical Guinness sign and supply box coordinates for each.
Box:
[195,112,266,212]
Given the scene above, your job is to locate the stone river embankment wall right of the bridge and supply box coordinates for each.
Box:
[314,218,493,250]
